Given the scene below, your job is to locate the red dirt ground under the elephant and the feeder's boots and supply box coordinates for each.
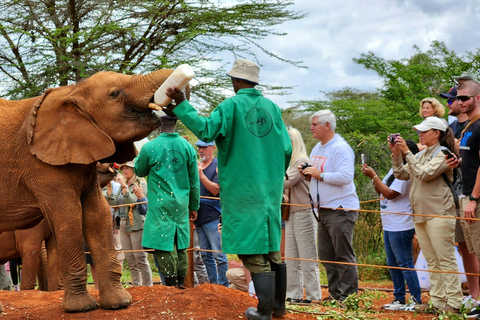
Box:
[0,284,436,320]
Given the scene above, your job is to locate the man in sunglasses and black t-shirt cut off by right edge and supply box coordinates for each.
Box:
[447,73,480,313]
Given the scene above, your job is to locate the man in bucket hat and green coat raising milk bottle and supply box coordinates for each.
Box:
[167,59,292,319]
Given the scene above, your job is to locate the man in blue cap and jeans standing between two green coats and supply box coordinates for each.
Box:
[194,140,228,287]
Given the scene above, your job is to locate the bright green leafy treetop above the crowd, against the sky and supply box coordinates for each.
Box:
[353,41,480,127]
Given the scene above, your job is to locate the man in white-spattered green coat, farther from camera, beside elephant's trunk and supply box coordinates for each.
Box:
[135,116,200,287]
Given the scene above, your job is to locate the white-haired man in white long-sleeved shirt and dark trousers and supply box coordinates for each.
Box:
[300,110,360,301]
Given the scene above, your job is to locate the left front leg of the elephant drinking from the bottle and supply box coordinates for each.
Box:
[45,201,98,312]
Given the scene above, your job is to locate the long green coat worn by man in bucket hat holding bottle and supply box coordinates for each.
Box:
[173,89,292,254]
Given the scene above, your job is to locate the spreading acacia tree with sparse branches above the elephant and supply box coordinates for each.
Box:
[0,0,304,103]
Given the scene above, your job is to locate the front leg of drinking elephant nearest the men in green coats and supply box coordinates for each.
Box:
[83,189,132,309]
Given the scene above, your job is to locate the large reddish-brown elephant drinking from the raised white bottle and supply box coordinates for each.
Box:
[0,70,172,312]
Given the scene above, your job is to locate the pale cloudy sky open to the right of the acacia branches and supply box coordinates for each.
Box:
[239,0,480,107]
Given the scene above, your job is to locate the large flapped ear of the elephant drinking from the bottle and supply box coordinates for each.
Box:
[27,86,115,165]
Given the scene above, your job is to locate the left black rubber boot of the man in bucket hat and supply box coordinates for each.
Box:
[245,272,275,320]
